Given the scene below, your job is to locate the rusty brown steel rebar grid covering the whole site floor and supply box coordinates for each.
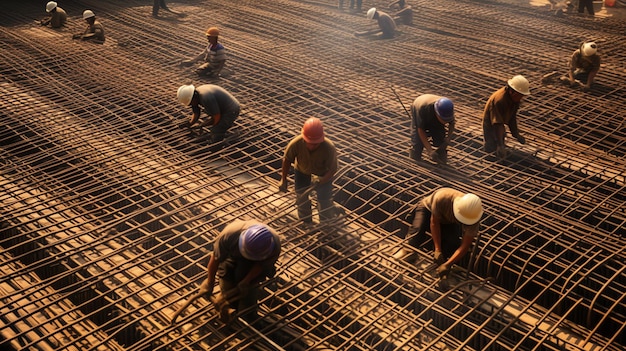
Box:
[0,1,626,350]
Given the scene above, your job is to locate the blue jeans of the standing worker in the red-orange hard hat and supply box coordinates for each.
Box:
[294,170,335,223]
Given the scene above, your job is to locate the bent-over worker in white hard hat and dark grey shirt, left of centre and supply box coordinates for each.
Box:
[176,84,241,143]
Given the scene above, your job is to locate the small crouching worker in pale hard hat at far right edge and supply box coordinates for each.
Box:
[561,42,601,91]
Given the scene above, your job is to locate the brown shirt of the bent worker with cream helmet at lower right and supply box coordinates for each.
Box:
[422,188,480,236]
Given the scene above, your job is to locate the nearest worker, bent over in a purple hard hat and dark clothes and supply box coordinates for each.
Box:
[201,220,281,320]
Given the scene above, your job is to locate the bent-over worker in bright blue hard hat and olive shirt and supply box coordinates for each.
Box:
[409,94,454,164]
